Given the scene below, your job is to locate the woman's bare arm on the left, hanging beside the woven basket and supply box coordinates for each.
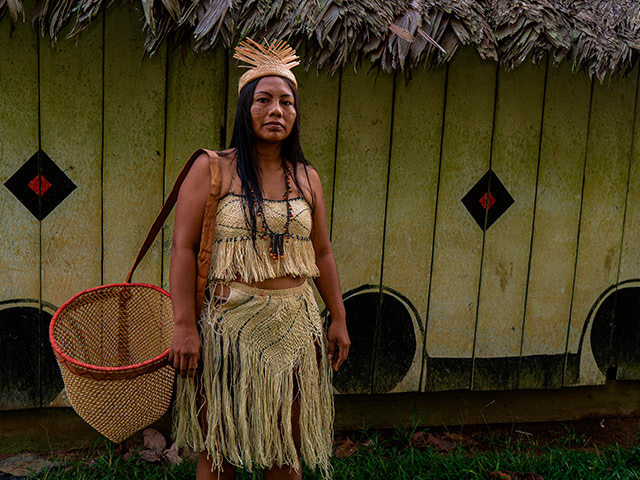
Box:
[169,153,211,378]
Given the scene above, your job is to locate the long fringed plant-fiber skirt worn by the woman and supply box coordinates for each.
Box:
[174,282,334,478]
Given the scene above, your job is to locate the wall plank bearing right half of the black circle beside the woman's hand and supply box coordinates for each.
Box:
[374,66,446,392]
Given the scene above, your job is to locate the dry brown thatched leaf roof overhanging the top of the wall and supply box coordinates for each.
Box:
[0,0,640,80]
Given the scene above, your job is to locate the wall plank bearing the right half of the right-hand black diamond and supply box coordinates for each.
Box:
[472,63,546,390]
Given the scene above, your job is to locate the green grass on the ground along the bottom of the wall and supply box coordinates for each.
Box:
[34,432,640,480]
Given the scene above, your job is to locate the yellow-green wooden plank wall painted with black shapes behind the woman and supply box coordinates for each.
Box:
[0,4,640,409]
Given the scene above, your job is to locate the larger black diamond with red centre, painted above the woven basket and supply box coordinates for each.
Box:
[4,150,76,220]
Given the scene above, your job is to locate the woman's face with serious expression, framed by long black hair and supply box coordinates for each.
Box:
[251,77,297,143]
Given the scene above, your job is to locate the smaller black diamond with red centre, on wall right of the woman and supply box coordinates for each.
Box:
[462,170,514,231]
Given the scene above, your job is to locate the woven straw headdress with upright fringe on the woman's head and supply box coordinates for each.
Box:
[233,37,300,94]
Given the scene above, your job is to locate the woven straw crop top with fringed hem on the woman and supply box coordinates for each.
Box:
[209,193,320,283]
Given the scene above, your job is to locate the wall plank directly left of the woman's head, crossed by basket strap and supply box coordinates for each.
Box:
[162,48,227,289]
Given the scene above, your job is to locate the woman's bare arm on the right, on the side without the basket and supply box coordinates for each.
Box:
[307,168,351,371]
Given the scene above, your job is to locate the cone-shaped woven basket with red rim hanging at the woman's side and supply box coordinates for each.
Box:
[49,283,175,443]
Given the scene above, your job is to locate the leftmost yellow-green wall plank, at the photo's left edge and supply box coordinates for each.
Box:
[0,8,40,410]
